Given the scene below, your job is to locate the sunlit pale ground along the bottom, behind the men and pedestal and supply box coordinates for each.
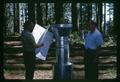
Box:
[4,69,116,80]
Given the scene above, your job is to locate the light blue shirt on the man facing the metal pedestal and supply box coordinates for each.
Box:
[85,29,103,50]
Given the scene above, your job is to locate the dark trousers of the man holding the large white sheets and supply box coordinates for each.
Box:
[23,52,35,80]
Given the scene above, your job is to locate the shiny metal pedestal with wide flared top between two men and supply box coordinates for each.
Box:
[54,24,72,80]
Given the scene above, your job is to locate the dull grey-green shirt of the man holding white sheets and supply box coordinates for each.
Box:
[21,30,35,52]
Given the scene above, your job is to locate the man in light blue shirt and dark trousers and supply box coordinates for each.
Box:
[84,21,103,79]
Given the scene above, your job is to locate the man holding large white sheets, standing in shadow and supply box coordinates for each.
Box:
[21,21,43,80]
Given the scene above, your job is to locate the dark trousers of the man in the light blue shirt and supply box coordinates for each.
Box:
[84,49,98,80]
